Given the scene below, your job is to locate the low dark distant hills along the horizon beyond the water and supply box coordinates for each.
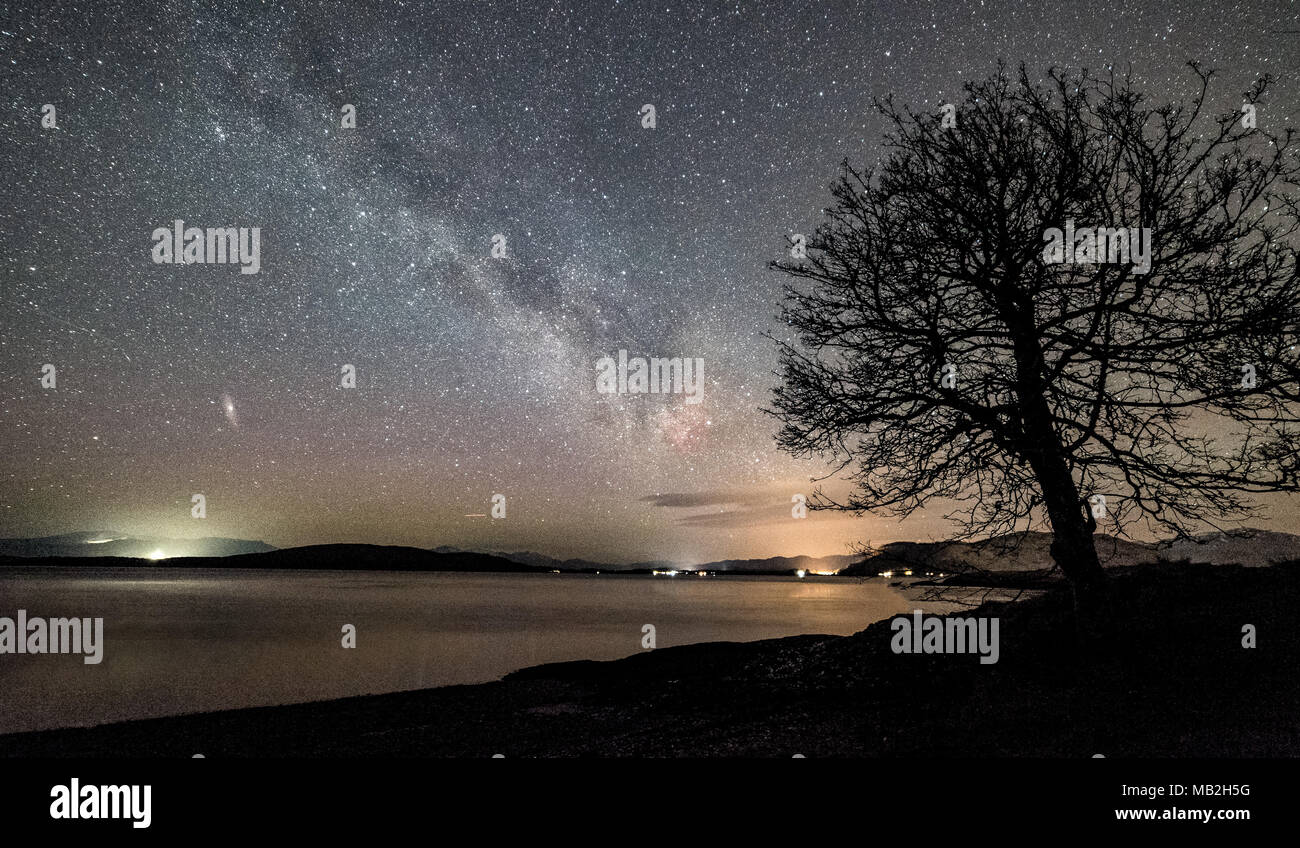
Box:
[0,529,1300,576]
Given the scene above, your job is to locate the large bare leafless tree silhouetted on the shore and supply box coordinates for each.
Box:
[767,64,1300,603]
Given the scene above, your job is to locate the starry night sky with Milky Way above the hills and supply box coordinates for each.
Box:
[0,0,1300,562]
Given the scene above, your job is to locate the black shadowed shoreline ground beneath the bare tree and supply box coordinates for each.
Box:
[0,564,1300,757]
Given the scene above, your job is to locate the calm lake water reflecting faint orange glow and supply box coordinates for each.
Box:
[0,568,915,732]
